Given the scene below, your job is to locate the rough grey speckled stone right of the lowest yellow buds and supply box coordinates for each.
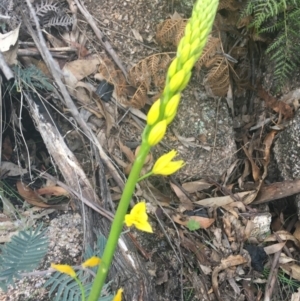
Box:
[167,88,236,181]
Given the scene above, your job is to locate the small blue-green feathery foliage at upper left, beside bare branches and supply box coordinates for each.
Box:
[12,65,53,91]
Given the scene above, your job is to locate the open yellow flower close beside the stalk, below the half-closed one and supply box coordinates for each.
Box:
[125,202,153,233]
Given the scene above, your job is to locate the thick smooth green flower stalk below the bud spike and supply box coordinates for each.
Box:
[88,140,150,301]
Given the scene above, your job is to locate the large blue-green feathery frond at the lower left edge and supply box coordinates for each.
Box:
[0,224,48,291]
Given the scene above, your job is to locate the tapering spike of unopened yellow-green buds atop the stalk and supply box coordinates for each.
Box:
[145,0,219,146]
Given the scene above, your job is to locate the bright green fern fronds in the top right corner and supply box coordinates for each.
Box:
[242,0,300,92]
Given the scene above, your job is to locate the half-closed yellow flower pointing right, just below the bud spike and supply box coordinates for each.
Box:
[152,149,184,176]
